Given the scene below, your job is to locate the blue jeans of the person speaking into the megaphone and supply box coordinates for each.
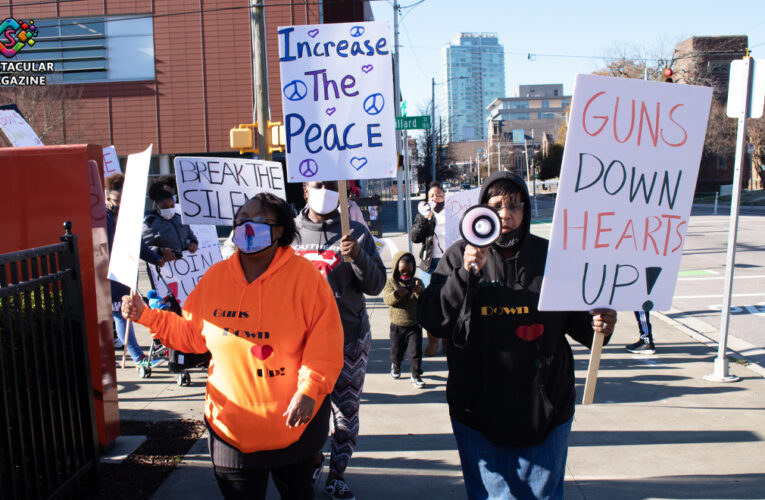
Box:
[452,417,573,500]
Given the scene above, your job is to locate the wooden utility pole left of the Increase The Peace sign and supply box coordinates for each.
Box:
[250,0,271,160]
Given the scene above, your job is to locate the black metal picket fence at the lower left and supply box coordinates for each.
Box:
[0,222,98,499]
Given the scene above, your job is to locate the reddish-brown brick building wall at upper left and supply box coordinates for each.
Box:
[0,0,328,156]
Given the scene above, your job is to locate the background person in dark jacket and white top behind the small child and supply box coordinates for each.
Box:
[409,182,446,356]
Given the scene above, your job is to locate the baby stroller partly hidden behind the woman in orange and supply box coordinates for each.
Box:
[139,269,211,386]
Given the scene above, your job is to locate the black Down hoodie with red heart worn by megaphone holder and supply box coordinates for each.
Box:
[417,172,609,446]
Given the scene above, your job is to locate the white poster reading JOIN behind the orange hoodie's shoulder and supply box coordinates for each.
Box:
[149,224,223,306]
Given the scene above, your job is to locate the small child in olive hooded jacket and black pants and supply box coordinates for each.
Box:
[383,252,425,389]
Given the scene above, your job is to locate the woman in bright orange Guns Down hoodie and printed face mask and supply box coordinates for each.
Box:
[122,193,343,499]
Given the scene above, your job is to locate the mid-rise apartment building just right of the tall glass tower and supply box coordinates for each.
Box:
[486,83,571,173]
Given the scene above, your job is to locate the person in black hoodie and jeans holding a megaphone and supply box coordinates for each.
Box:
[417,172,616,499]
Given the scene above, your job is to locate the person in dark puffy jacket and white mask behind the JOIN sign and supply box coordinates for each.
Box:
[141,182,199,262]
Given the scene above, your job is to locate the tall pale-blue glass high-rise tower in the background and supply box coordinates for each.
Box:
[441,33,505,142]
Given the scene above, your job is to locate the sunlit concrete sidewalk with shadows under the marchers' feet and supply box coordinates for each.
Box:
[112,232,765,500]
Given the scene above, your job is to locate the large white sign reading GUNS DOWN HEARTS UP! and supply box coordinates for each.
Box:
[539,75,712,311]
